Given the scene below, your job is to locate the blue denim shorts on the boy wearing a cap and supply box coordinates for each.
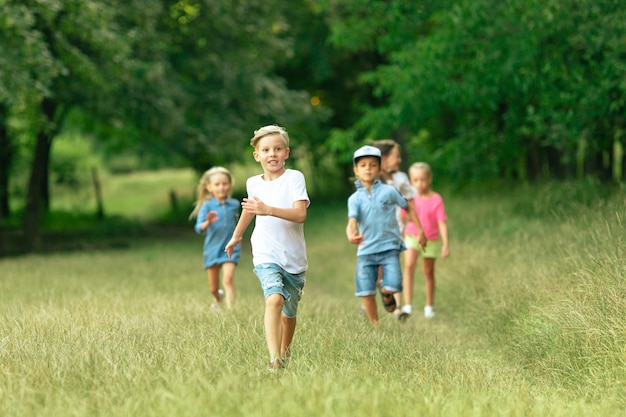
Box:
[354,249,402,297]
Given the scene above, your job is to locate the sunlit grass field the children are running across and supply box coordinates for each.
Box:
[0,171,626,417]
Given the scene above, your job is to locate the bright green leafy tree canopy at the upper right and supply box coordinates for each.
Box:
[322,0,626,178]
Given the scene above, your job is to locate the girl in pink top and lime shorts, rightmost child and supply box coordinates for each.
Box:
[402,162,450,318]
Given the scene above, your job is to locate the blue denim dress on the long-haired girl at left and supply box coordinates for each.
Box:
[194,198,241,268]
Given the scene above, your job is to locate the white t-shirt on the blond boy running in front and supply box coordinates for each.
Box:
[246,169,310,274]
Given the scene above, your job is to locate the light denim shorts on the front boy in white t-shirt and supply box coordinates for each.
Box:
[254,263,306,318]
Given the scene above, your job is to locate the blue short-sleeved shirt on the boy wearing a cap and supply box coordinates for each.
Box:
[348,180,408,256]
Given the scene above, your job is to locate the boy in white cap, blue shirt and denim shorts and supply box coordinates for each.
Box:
[346,146,408,326]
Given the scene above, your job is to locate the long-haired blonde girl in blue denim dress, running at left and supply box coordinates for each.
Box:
[189,167,241,308]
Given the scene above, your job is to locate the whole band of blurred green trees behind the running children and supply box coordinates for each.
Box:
[0,0,626,249]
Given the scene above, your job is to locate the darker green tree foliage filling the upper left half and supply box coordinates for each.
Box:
[0,0,325,247]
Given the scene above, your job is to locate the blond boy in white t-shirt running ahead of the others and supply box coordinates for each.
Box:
[225,125,310,371]
